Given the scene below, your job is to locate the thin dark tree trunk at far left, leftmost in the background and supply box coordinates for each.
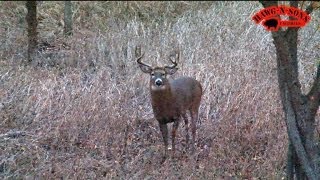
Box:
[26,1,38,62]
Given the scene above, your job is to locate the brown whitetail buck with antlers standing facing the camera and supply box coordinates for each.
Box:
[135,47,202,158]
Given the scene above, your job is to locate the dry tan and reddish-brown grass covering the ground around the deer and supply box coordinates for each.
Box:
[0,1,320,179]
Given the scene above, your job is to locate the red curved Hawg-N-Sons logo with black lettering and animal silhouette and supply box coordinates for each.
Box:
[252,6,311,31]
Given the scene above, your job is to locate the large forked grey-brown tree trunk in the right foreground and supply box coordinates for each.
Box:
[261,1,320,180]
